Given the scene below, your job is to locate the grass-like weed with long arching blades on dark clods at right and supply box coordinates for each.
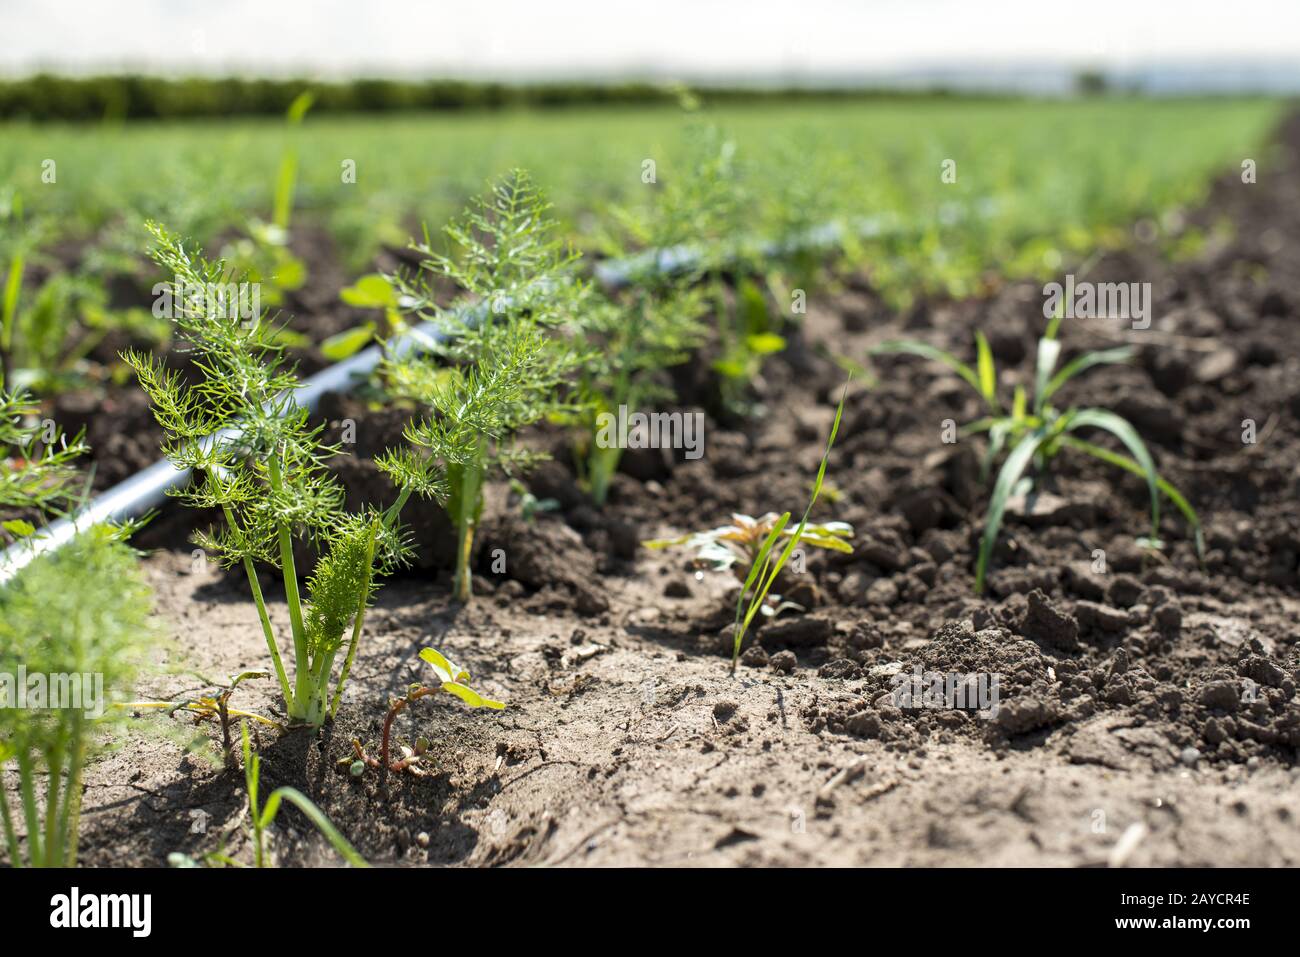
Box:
[872,317,1204,594]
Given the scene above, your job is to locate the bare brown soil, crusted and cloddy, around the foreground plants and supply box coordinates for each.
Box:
[45,115,1300,866]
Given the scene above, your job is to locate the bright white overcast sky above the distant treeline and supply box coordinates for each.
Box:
[0,0,1300,78]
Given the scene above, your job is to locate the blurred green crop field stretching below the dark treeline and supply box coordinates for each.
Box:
[0,99,1279,392]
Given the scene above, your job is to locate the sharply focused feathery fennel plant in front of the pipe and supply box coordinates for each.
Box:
[125,224,441,726]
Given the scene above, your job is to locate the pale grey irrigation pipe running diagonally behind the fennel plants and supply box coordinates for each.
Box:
[0,202,992,584]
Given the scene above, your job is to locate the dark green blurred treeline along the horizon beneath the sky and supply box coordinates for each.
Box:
[0,74,977,121]
